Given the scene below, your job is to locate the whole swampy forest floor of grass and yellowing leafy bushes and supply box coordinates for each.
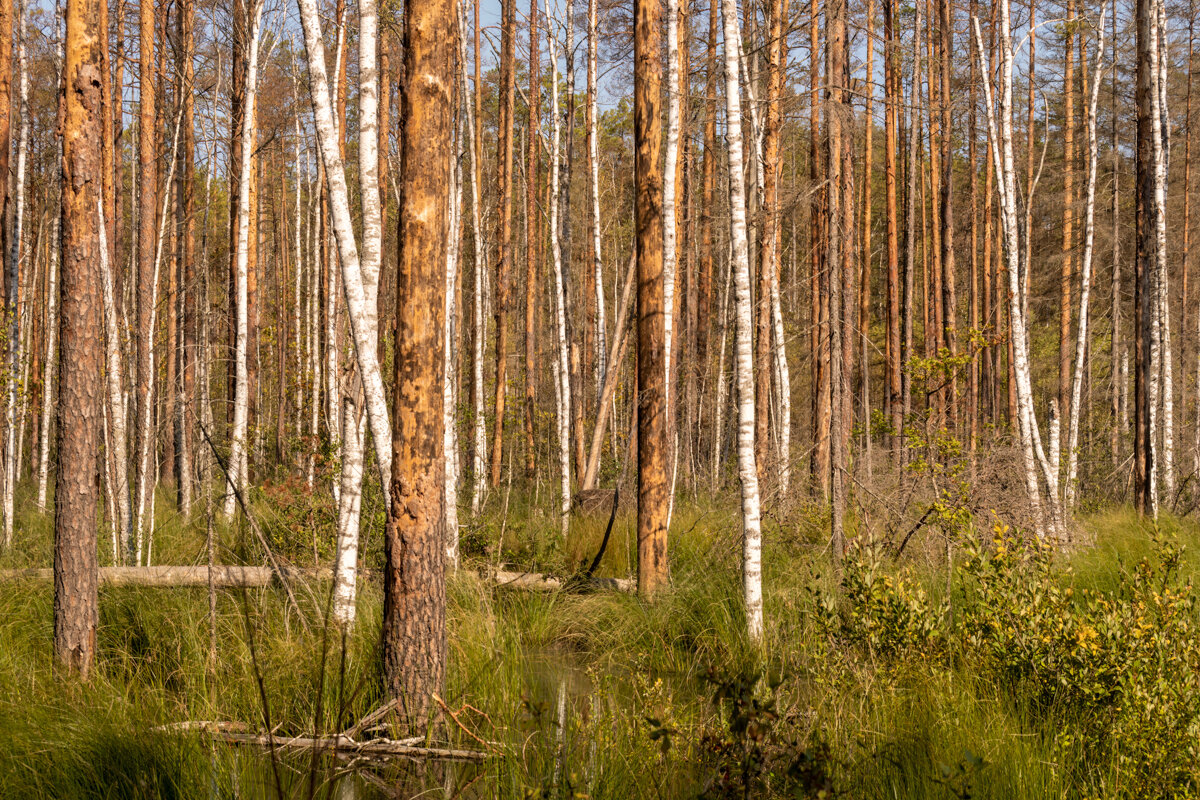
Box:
[0,482,1200,799]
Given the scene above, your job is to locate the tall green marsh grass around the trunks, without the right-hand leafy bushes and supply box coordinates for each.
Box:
[0,479,1198,799]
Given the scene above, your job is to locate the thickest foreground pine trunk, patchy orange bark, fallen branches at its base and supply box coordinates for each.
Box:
[384,0,456,728]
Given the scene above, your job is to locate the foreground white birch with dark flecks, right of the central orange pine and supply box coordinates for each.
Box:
[721,0,763,643]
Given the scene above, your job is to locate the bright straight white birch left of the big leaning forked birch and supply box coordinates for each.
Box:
[224,0,263,520]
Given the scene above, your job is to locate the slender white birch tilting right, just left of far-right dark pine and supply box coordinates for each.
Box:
[1063,28,1104,510]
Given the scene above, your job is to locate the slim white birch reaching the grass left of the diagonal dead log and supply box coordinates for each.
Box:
[547,12,573,539]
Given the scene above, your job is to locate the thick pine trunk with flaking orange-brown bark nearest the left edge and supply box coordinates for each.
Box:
[54,0,103,679]
